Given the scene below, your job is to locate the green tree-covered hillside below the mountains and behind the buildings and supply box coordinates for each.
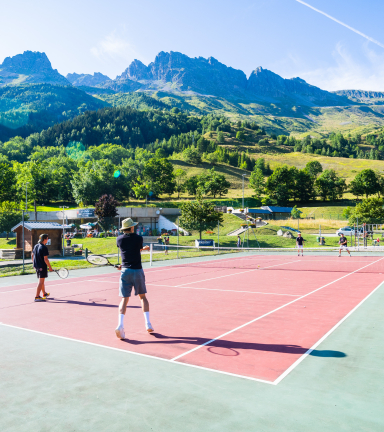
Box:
[0,103,384,213]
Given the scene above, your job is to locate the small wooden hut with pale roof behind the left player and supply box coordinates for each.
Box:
[11,222,63,256]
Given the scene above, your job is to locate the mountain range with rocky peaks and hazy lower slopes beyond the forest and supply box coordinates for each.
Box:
[0,51,384,141]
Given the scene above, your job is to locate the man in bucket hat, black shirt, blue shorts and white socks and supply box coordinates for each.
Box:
[115,218,153,339]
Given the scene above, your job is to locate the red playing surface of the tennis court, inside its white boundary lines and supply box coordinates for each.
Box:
[0,256,384,384]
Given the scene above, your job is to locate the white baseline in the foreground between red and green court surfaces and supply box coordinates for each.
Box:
[0,322,274,385]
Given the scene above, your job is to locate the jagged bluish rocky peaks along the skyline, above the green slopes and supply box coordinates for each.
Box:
[0,51,372,106]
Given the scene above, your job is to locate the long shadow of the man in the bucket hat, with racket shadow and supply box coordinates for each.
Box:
[123,332,347,358]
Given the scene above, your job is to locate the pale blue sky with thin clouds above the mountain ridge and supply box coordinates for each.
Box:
[0,0,384,91]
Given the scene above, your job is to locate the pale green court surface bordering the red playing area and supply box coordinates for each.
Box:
[0,260,384,432]
